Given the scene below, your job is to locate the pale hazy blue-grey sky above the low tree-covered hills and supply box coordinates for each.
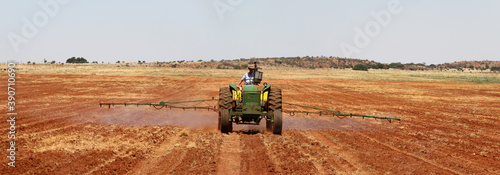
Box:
[0,0,500,64]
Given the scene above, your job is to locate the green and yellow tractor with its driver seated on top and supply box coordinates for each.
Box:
[218,63,283,135]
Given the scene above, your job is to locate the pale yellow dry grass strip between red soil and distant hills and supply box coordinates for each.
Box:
[4,64,500,83]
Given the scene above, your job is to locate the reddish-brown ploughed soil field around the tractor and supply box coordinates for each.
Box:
[0,74,500,174]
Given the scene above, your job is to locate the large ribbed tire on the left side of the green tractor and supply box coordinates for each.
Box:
[217,87,233,133]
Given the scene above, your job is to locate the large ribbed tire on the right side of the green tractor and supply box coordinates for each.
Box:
[266,88,282,134]
